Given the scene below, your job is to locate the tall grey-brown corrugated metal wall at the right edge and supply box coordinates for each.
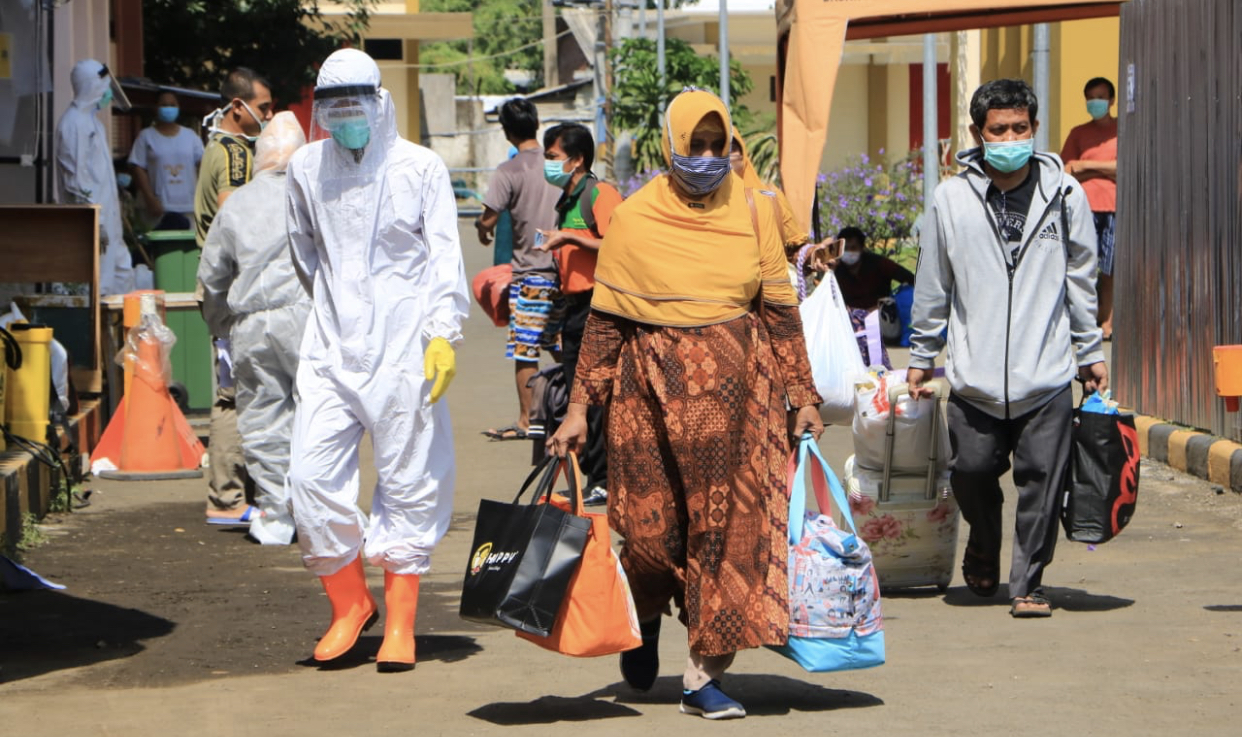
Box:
[1113,0,1242,440]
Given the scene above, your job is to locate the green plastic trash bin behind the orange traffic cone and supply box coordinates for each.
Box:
[144,230,215,411]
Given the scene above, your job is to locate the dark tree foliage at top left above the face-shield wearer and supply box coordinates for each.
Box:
[143,0,376,106]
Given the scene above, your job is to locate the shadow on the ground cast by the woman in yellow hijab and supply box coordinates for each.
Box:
[469,674,884,727]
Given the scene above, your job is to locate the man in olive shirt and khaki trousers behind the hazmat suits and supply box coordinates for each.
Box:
[194,67,272,524]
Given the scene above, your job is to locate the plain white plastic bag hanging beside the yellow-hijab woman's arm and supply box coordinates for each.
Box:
[801,273,867,425]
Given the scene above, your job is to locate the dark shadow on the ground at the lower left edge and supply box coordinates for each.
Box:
[0,590,176,682]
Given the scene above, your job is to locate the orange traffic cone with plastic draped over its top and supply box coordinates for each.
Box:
[96,337,202,480]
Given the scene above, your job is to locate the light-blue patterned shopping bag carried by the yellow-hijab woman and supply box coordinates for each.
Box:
[771,435,884,672]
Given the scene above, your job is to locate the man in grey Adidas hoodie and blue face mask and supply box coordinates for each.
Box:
[908,80,1108,616]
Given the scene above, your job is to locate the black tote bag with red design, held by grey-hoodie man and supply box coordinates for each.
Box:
[1061,409,1139,543]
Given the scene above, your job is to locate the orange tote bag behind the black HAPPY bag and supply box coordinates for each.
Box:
[517,454,642,657]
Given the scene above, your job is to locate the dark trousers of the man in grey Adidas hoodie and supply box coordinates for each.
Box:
[949,387,1073,597]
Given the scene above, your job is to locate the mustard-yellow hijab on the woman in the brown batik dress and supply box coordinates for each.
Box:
[591,89,797,327]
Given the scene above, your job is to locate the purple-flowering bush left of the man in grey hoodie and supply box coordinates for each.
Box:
[816,149,923,256]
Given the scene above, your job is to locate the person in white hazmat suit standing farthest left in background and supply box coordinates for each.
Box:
[56,58,134,295]
